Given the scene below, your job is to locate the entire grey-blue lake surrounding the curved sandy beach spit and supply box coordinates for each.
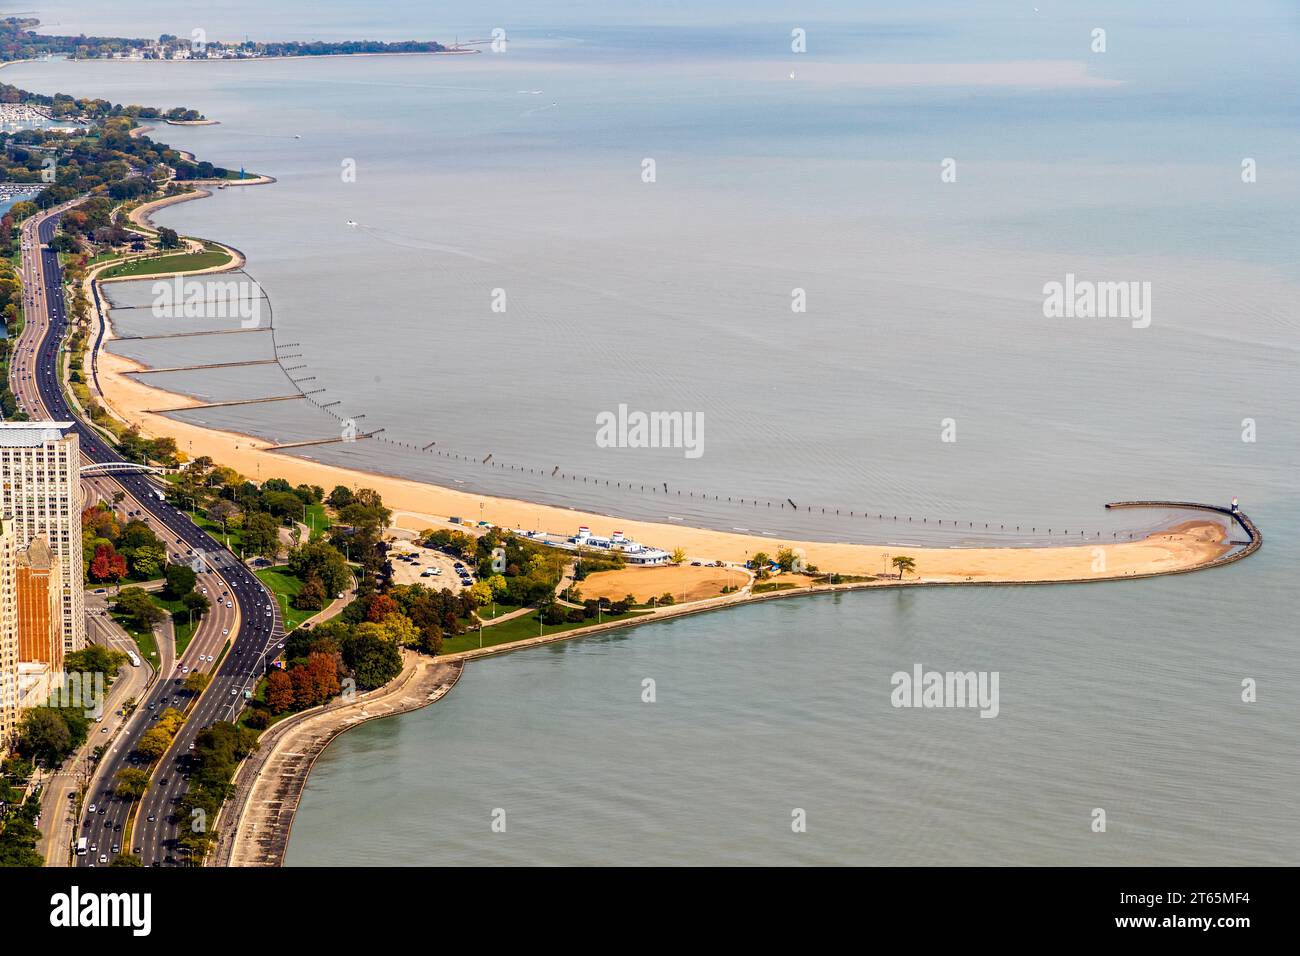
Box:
[12,3,1300,865]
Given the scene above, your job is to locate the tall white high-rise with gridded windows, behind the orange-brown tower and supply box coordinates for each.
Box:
[0,421,86,652]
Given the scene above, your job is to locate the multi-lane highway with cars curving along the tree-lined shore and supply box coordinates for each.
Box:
[10,207,283,866]
